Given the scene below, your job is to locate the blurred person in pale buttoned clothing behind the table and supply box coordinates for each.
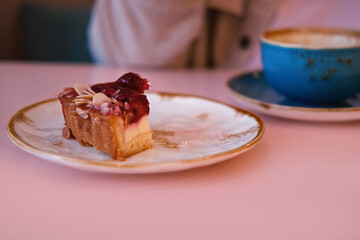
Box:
[88,0,360,70]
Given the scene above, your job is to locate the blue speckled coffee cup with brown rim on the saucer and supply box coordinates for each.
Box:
[261,28,360,104]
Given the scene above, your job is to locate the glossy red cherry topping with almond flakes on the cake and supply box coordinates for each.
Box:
[58,72,150,123]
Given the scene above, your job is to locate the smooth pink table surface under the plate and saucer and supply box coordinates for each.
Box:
[0,62,360,240]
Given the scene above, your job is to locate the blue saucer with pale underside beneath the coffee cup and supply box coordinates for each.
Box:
[227,72,360,122]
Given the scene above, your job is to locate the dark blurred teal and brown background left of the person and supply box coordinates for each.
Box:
[0,0,94,62]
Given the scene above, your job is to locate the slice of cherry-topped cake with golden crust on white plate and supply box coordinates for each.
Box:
[58,72,153,160]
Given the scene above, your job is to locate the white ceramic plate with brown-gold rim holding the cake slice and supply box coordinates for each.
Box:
[7,93,264,173]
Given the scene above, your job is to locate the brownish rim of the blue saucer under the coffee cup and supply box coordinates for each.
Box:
[226,70,360,112]
